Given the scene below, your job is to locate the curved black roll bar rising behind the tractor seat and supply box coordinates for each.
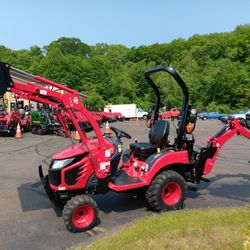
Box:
[144,65,189,148]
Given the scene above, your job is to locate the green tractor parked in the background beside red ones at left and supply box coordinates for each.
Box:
[30,110,61,135]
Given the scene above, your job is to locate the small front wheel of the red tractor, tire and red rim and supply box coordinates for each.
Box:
[63,195,98,233]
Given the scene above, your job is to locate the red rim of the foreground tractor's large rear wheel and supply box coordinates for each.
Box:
[162,182,181,206]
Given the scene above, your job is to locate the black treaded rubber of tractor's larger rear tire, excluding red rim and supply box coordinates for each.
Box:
[145,170,187,212]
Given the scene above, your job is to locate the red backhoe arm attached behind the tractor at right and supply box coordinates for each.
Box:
[196,120,250,183]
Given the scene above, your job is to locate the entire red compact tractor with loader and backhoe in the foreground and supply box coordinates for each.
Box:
[0,63,250,232]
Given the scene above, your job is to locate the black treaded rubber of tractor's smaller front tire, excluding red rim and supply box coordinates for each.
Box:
[63,195,98,233]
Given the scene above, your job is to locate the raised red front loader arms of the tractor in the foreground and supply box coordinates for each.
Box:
[0,62,109,175]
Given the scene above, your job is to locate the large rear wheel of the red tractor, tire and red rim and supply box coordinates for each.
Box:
[145,170,187,212]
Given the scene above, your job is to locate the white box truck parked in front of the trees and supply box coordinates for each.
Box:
[104,103,147,119]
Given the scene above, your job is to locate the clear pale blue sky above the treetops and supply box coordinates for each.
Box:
[0,0,250,49]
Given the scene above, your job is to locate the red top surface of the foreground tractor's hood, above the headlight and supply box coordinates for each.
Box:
[52,139,99,160]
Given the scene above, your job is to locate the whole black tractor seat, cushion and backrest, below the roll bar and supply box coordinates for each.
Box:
[129,120,170,157]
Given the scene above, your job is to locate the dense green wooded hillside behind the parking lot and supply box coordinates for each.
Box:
[0,25,250,112]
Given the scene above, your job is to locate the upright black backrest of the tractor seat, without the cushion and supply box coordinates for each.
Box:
[149,120,170,146]
